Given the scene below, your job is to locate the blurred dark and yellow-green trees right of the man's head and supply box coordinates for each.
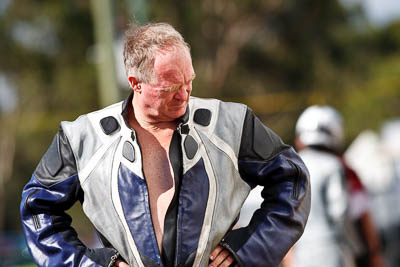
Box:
[150,0,399,142]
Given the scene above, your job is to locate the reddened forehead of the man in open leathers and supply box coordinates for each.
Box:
[154,47,194,83]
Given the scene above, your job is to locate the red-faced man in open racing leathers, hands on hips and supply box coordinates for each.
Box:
[21,23,310,266]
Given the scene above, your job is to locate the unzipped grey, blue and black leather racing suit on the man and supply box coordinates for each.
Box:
[20,94,310,267]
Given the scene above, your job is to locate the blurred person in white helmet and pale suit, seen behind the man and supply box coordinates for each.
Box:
[285,106,383,267]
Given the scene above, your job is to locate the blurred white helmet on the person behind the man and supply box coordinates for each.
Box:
[296,106,343,151]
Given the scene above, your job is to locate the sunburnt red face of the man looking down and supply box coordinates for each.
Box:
[140,48,195,122]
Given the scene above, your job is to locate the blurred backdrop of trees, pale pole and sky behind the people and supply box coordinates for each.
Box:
[0,0,400,266]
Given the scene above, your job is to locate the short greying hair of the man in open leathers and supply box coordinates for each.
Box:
[124,23,190,83]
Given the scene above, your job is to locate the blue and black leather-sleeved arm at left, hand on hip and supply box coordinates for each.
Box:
[20,130,119,266]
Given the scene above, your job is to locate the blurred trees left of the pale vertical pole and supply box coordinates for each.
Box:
[0,0,99,233]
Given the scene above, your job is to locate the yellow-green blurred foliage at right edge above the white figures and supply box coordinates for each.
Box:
[339,22,400,140]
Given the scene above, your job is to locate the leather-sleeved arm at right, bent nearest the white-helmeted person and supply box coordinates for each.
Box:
[221,110,310,266]
